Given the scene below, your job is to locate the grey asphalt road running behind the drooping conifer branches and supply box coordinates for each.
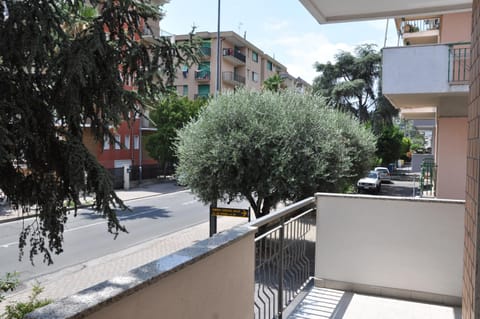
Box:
[0,190,248,281]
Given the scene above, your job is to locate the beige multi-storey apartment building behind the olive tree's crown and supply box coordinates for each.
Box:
[174,31,296,99]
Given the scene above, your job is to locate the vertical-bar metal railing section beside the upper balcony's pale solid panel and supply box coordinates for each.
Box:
[448,43,471,84]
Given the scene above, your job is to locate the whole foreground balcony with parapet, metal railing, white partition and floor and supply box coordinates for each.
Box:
[28,194,464,319]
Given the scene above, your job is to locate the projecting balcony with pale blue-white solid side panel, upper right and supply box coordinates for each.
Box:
[382,43,470,109]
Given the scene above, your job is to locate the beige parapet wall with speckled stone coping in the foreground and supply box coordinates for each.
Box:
[27,226,256,319]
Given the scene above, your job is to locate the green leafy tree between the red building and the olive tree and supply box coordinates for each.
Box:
[146,93,207,175]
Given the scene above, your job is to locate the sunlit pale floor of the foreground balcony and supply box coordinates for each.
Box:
[288,287,462,319]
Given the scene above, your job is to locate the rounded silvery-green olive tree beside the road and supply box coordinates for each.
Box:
[176,90,375,218]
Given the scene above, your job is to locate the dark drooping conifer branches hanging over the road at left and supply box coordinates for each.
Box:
[0,0,198,263]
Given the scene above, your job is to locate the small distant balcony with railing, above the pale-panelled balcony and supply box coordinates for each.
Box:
[400,17,441,45]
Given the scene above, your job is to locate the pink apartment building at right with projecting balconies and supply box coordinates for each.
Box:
[383,10,472,199]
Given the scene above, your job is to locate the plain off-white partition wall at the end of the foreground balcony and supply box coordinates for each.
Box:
[315,194,464,301]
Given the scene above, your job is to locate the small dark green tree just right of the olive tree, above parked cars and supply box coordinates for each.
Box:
[376,125,403,165]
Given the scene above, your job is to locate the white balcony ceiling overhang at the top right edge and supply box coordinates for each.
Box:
[300,0,472,24]
